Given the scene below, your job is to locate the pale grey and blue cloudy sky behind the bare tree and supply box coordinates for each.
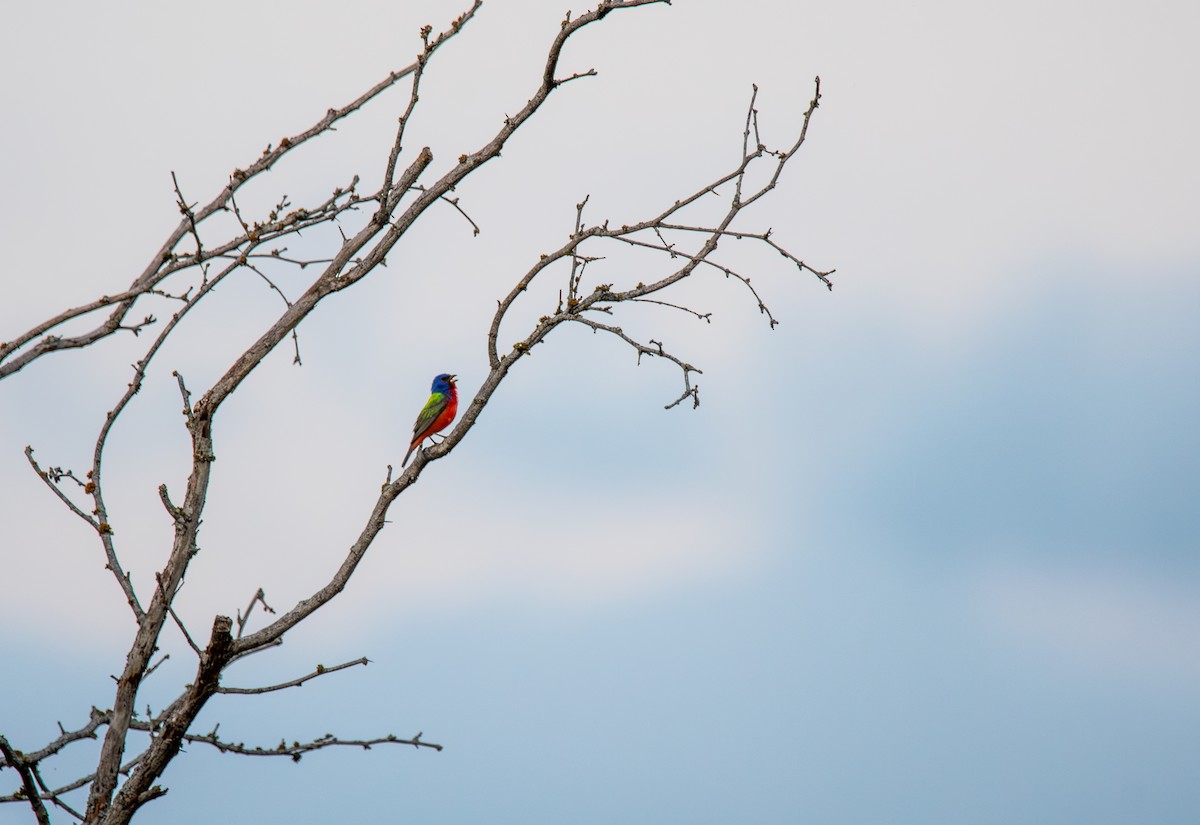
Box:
[0,0,1200,825]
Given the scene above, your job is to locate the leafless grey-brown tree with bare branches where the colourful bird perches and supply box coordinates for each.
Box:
[0,0,832,824]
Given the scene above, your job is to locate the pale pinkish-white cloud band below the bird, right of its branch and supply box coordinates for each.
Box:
[309,477,761,632]
